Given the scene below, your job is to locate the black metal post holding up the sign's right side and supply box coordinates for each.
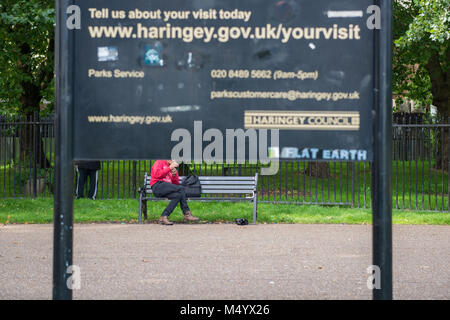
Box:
[372,0,392,300]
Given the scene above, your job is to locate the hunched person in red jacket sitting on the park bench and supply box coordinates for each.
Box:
[150,160,199,225]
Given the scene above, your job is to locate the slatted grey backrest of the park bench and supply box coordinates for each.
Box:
[145,173,258,194]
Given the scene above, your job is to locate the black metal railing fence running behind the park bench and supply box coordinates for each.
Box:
[0,115,450,211]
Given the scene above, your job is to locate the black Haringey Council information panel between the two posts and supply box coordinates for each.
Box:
[71,0,374,161]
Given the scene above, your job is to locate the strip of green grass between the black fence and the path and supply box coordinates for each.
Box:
[0,198,450,225]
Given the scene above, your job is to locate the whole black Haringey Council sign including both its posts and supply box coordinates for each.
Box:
[53,0,392,299]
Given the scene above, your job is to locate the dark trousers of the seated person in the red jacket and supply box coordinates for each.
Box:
[152,181,190,216]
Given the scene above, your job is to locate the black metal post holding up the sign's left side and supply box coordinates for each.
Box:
[53,0,73,300]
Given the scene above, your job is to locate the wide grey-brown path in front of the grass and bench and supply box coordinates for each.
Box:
[0,224,450,300]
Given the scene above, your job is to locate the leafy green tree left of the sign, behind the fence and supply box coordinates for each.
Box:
[0,0,55,167]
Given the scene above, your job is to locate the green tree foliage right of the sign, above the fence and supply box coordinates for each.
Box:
[393,0,450,114]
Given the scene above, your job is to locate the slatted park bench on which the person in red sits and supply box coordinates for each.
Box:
[138,173,258,224]
